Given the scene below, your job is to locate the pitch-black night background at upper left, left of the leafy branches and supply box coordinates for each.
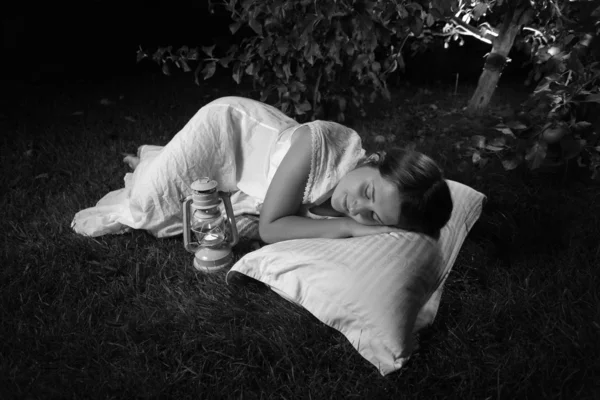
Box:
[0,0,229,81]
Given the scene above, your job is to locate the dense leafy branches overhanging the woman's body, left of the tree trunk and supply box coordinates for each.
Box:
[138,0,451,121]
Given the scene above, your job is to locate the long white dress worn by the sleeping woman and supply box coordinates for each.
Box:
[71,97,365,237]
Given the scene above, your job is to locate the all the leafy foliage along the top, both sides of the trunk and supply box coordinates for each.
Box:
[138,0,600,177]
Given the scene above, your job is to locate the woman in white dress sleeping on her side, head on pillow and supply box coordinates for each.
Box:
[72,97,453,243]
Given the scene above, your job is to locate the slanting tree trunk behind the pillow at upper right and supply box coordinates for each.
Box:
[467,8,531,116]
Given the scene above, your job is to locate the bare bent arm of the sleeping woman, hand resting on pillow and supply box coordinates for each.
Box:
[259,126,396,243]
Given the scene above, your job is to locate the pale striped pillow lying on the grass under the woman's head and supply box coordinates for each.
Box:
[227,181,485,375]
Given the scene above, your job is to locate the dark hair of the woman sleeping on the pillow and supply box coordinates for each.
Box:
[366,148,453,239]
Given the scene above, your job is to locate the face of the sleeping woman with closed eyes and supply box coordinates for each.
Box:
[331,166,400,225]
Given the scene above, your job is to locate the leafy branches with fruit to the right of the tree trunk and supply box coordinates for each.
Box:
[450,1,600,179]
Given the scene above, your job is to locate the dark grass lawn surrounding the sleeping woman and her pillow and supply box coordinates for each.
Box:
[0,72,600,399]
